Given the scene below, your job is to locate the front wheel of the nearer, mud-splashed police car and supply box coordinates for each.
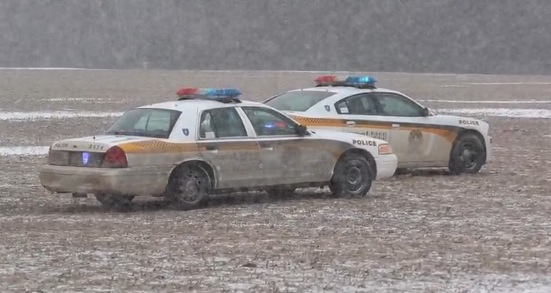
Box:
[329,154,373,198]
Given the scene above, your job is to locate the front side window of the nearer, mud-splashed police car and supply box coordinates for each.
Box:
[242,107,297,136]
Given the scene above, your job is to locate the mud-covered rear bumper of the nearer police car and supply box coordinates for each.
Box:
[39,165,169,196]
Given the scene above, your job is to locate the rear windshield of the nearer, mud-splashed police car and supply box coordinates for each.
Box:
[106,108,181,138]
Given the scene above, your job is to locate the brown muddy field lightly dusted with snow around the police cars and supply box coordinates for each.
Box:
[0,70,551,292]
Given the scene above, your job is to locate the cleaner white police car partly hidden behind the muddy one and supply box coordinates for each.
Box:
[264,75,492,174]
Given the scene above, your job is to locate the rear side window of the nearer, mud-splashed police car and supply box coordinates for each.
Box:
[199,107,247,139]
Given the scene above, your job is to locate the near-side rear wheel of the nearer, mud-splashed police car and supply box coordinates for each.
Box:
[165,165,212,210]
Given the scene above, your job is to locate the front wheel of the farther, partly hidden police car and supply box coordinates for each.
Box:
[449,133,486,175]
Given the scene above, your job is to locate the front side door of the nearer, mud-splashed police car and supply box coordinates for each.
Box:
[241,106,328,185]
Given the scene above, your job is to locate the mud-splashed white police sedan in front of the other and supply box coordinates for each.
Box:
[39,88,397,209]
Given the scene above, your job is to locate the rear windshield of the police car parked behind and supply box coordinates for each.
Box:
[265,91,335,112]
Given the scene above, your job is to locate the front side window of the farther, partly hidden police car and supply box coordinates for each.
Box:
[376,93,423,117]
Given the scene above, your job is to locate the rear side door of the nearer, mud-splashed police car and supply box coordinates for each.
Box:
[197,107,263,188]
